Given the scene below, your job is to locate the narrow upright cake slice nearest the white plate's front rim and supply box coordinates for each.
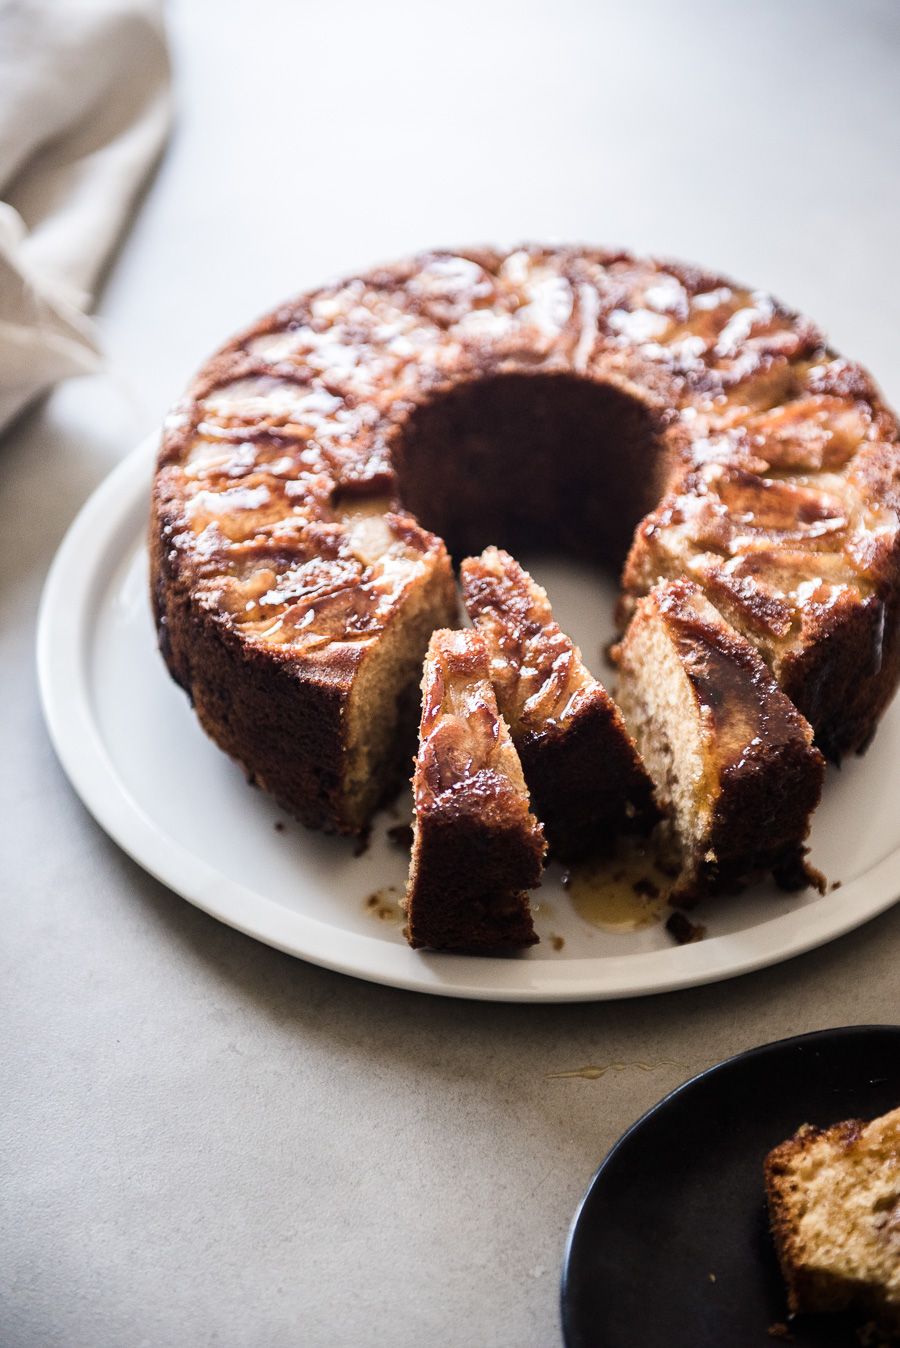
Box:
[406,628,544,952]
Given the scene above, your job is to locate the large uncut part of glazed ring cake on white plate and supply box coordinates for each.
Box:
[151,247,900,830]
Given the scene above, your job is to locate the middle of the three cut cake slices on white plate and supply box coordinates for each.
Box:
[461,547,653,859]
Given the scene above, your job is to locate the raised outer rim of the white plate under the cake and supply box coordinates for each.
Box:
[36,433,900,1002]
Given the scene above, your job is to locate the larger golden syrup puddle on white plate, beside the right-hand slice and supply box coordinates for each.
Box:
[563,840,672,934]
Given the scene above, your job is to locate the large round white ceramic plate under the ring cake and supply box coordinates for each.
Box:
[38,437,900,1002]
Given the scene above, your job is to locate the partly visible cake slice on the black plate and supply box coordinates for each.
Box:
[765,1108,900,1333]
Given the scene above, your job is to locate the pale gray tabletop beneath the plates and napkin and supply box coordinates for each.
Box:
[0,0,900,1348]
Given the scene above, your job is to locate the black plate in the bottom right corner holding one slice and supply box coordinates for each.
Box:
[562,1026,900,1348]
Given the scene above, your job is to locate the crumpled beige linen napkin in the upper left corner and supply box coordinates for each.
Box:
[0,0,170,429]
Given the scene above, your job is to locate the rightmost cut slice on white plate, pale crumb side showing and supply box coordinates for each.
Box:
[616,581,825,905]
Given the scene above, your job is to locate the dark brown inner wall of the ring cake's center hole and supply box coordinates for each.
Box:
[393,373,666,569]
